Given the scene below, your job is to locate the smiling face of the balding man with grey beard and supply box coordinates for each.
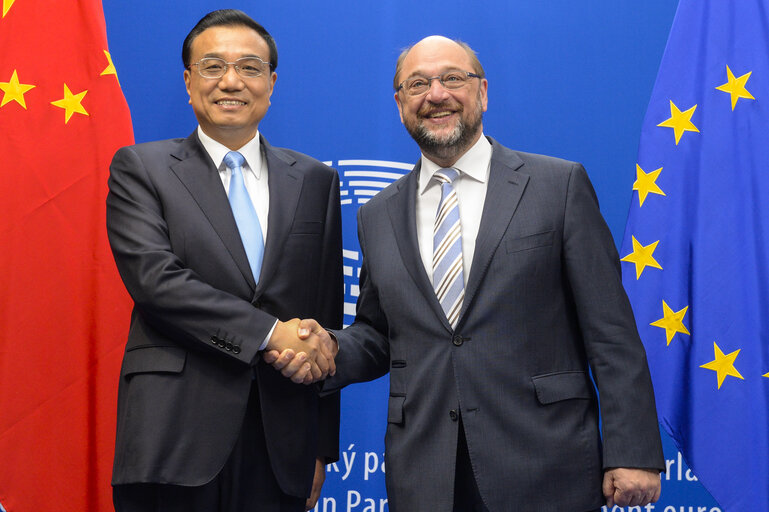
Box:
[395,36,488,167]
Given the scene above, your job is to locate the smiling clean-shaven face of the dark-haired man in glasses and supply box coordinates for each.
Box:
[184,25,277,150]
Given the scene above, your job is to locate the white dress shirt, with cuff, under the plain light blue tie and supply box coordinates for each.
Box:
[198,126,278,350]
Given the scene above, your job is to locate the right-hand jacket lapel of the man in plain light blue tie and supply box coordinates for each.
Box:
[256,136,304,295]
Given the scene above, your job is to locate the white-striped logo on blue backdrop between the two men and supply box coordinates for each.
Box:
[324,160,414,326]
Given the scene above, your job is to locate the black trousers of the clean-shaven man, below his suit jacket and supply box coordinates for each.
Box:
[112,385,305,512]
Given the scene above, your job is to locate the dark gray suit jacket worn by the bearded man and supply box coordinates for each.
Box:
[327,140,664,512]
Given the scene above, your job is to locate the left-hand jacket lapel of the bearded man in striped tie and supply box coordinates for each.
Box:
[387,161,452,331]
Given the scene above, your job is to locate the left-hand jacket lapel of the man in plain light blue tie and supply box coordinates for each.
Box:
[171,130,254,288]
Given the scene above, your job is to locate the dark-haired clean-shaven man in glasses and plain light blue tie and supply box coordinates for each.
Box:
[107,10,343,512]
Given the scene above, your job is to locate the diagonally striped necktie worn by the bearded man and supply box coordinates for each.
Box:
[433,169,465,327]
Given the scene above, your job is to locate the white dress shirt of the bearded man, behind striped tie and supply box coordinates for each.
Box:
[416,134,491,285]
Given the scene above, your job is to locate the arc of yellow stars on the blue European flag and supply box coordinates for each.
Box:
[622,65,769,389]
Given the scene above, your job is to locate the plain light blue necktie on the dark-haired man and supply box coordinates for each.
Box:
[224,151,264,283]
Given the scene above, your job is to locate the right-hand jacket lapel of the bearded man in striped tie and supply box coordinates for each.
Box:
[458,138,529,325]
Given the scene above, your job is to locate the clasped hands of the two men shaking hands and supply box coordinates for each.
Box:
[262,318,332,384]
